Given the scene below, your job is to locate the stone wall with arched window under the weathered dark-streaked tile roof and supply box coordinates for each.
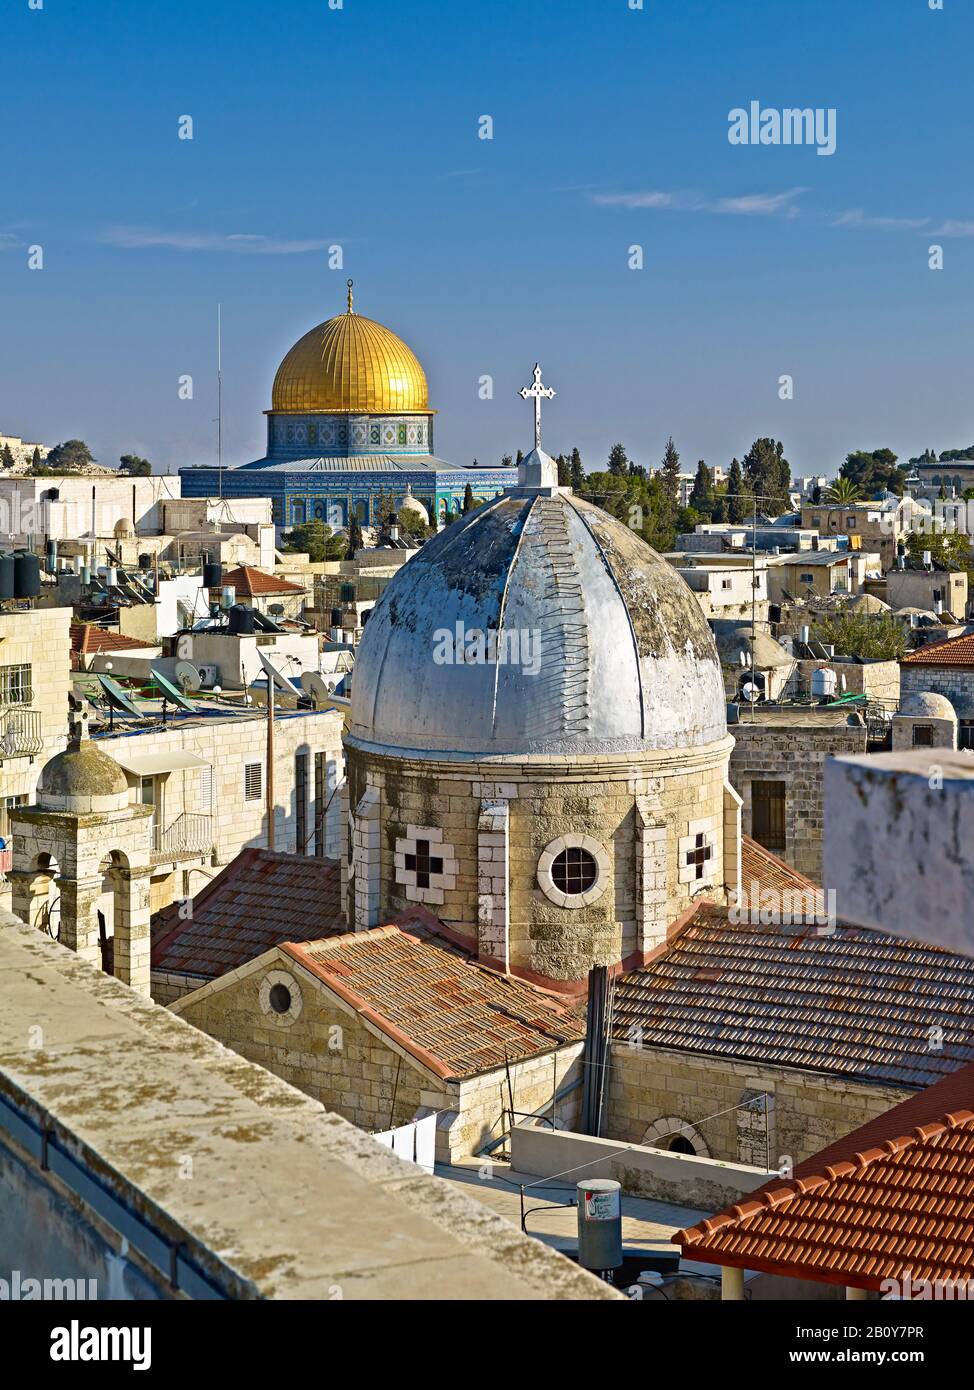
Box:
[606,1043,910,1169]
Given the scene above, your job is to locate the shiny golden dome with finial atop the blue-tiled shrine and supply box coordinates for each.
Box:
[271,281,429,414]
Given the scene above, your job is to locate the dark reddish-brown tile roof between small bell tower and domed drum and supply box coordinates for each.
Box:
[151,849,347,981]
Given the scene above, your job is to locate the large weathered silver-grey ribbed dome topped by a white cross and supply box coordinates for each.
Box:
[350,491,727,756]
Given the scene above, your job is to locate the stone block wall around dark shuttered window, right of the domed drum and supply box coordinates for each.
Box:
[731,710,866,883]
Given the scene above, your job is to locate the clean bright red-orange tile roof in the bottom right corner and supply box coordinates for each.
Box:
[672,1066,974,1290]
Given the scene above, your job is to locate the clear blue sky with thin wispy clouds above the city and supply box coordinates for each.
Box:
[0,0,974,473]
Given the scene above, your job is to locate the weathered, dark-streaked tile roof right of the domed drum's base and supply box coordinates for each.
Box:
[613,905,974,1088]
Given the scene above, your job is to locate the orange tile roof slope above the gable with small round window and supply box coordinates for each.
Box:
[282,924,585,1079]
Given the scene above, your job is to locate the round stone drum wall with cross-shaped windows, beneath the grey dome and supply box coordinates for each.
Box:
[346,739,729,981]
